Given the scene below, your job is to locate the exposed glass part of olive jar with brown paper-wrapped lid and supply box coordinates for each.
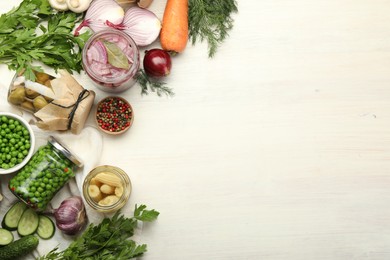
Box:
[7,71,55,113]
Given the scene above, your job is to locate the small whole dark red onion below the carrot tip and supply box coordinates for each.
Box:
[144,49,172,77]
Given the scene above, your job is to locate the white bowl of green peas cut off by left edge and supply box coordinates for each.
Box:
[0,112,35,174]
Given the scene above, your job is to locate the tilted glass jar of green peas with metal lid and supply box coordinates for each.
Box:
[8,136,82,211]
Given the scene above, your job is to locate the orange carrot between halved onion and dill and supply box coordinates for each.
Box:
[160,0,188,52]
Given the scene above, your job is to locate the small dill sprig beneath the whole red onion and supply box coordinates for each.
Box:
[136,69,175,97]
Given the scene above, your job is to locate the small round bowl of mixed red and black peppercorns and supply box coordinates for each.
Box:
[95,96,134,135]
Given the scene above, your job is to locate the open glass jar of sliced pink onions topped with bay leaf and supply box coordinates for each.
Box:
[82,29,140,93]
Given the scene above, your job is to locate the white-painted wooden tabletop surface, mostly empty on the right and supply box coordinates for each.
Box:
[1,0,390,260]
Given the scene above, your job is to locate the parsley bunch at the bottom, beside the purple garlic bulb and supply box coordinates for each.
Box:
[39,205,159,260]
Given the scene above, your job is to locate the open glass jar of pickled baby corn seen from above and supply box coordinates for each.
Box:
[83,165,132,213]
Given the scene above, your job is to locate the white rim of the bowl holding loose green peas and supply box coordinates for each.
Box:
[0,112,35,175]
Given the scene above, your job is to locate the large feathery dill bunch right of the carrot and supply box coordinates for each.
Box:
[188,0,238,58]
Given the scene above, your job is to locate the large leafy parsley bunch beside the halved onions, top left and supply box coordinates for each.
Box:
[0,0,90,80]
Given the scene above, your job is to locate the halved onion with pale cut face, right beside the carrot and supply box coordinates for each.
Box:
[121,7,161,46]
